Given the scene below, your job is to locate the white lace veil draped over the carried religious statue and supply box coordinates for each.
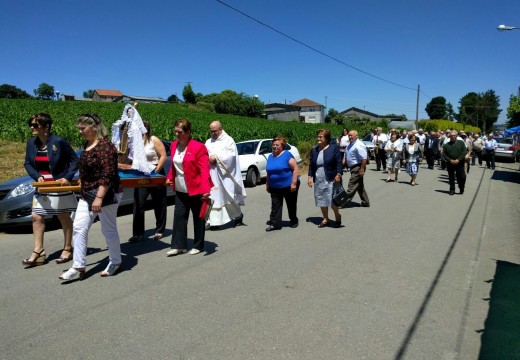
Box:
[112,104,154,175]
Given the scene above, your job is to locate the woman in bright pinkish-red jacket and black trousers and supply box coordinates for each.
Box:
[166,119,213,256]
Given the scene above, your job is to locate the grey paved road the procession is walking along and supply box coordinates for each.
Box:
[0,164,520,359]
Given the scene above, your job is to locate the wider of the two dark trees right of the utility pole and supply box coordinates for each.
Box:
[456,90,502,132]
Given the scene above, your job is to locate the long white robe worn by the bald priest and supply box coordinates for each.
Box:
[206,130,247,226]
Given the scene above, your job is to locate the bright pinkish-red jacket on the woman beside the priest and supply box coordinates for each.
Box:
[167,139,213,196]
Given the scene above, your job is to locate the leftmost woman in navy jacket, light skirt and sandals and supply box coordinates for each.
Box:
[22,113,78,267]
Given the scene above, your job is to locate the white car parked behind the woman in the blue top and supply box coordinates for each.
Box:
[237,139,302,187]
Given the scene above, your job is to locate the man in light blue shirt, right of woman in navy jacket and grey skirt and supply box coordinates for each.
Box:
[343,130,370,207]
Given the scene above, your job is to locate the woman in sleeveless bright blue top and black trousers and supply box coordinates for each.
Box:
[265,136,300,231]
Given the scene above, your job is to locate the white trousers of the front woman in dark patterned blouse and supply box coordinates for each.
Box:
[72,193,123,269]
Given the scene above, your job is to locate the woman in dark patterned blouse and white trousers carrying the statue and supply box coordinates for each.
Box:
[59,114,123,280]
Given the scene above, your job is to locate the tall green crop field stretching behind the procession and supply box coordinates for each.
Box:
[0,99,373,148]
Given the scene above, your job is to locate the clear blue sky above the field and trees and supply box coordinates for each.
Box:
[0,0,520,123]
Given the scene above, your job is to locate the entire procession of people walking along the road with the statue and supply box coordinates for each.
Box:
[22,109,497,280]
